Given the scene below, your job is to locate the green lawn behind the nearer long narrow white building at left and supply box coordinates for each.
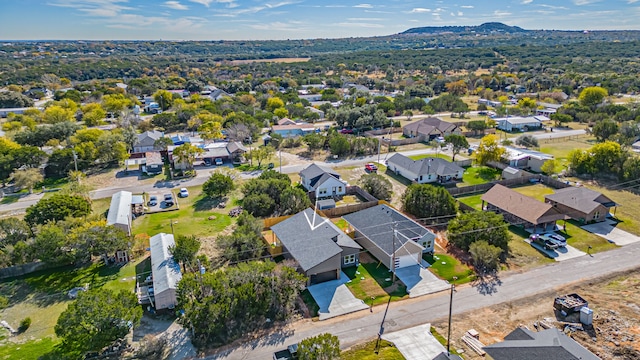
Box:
[133,186,237,237]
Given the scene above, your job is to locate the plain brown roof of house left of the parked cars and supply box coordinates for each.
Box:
[481,184,565,224]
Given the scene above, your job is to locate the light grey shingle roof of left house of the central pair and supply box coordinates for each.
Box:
[271,208,362,271]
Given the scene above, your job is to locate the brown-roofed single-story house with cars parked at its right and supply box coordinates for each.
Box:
[481,184,566,233]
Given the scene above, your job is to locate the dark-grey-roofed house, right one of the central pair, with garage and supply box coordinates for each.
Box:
[342,204,436,269]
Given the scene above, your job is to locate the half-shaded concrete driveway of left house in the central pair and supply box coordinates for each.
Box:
[307,272,369,320]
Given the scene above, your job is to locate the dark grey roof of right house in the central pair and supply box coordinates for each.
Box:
[342,205,436,255]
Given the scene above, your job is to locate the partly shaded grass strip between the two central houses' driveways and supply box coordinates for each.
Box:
[343,263,408,305]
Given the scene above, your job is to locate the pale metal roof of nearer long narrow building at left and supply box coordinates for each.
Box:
[149,233,182,294]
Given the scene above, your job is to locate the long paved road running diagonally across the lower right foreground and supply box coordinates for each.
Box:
[206,243,640,360]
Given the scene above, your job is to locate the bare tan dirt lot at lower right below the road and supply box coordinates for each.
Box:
[433,270,640,360]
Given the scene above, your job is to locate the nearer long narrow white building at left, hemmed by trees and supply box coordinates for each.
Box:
[149,233,182,310]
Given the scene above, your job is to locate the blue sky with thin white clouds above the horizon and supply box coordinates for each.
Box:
[0,0,640,40]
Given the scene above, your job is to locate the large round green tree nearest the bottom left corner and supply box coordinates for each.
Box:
[55,289,142,356]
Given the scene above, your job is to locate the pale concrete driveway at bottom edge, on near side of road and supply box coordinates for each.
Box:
[382,324,447,360]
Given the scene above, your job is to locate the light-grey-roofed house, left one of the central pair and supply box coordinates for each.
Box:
[271,208,362,285]
